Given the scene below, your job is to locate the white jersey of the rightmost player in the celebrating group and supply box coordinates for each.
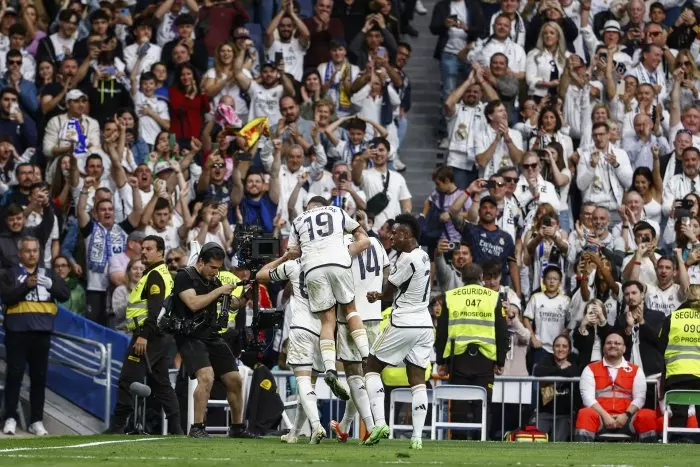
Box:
[389,248,433,328]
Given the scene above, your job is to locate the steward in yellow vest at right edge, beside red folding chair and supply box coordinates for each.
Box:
[657,285,700,440]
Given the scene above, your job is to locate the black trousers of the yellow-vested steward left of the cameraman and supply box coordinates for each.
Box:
[112,335,180,427]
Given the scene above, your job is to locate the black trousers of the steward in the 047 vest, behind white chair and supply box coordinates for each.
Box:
[450,353,494,439]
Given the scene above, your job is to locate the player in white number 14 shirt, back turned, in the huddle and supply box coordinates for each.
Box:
[331,235,390,442]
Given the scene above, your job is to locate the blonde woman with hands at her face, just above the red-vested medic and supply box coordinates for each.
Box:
[574,298,612,365]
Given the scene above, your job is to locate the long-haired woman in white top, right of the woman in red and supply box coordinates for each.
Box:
[202,42,249,123]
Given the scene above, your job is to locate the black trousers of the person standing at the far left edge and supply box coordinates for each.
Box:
[5,331,51,423]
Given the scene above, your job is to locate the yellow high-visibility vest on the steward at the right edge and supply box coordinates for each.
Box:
[664,308,700,378]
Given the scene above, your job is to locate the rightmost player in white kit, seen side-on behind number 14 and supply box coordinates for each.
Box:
[365,214,435,449]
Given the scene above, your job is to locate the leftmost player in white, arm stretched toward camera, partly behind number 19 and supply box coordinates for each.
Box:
[255,254,326,444]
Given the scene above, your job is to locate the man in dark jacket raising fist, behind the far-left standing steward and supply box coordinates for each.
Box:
[0,200,54,272]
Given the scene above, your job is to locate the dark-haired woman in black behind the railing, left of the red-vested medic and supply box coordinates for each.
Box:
[530,335,581,441]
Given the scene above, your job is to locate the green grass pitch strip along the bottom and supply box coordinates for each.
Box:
[0,436,700,467]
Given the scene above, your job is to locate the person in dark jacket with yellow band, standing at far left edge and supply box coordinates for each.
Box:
[0,236,70,436]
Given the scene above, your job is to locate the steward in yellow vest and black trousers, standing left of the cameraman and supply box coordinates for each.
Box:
[107,235,184,435]
